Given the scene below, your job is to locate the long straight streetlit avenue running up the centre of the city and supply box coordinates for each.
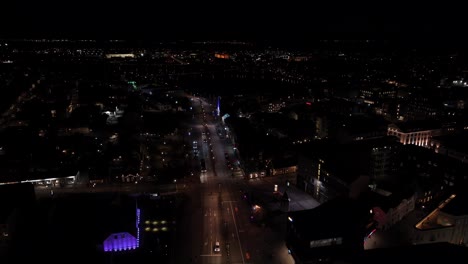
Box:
[176,97,245,263]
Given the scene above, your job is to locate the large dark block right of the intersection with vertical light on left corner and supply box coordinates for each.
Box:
[297,137,401,202]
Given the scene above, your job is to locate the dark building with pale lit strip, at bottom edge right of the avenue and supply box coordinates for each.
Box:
[286,198,369,263]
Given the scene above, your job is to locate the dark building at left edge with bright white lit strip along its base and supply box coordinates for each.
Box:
[0,127,81,186]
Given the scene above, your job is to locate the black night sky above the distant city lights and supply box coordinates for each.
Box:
[0,0,468,39]
